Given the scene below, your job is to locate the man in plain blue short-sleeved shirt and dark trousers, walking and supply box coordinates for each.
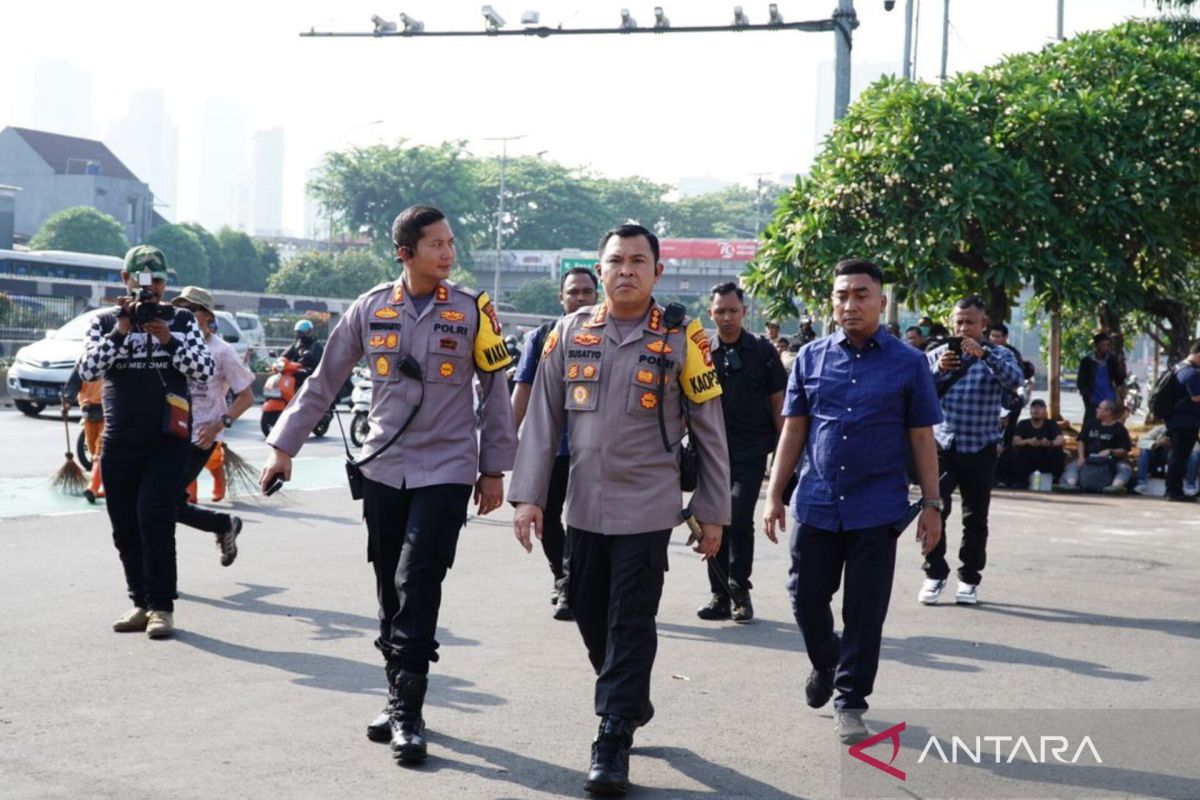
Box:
[763,259,942,744]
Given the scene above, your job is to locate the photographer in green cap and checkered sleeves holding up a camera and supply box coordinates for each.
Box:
[78,245,214,638]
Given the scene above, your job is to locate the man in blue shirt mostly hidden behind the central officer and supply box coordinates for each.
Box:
[512,266,599,620]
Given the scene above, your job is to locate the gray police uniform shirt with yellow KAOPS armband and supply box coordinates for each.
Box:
[509,302,730,535]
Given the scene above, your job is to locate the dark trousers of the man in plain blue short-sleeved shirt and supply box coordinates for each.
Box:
[787,525,896,710]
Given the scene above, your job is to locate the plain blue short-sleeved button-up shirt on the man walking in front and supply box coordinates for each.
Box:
[784,327,942,530]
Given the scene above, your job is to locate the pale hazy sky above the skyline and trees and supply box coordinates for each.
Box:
[0,0,1185,233]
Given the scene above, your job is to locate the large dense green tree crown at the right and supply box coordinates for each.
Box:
[750,20,1200,362]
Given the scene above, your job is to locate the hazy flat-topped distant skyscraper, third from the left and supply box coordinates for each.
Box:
[199,100,250,231]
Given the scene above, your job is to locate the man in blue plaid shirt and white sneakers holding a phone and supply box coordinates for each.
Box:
[918,296,1022,606]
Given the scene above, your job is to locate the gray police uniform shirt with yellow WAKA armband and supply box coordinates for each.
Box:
[266,279,516,488]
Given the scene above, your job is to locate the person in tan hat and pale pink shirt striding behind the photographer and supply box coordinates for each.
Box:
[170,287,254,566]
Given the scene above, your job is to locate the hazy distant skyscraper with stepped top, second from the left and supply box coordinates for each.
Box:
[107,89,179,221]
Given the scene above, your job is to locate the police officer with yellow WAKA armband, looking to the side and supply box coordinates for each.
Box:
[262,206,516,763]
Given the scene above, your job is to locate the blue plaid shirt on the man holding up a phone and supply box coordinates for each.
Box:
[929,344,1025,453]
